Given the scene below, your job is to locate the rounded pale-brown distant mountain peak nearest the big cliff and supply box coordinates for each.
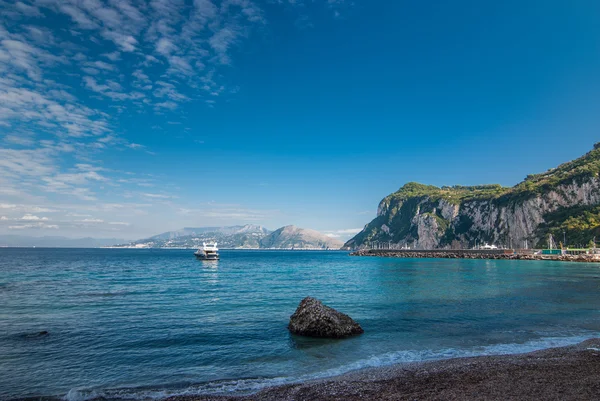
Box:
[260,226,344,249]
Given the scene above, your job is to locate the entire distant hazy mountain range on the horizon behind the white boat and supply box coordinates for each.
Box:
[117,224,343,249]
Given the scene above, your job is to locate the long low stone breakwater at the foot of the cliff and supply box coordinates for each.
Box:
[350,249,600,263]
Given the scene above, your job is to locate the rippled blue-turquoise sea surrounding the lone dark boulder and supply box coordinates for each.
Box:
[0,249,600,400]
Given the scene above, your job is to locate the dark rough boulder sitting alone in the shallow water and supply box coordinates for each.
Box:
[288,297,364,338]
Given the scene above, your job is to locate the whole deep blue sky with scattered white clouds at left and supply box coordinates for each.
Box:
[0,0,600,240]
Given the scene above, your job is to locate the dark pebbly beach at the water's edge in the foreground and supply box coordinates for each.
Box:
[168,339,600,401]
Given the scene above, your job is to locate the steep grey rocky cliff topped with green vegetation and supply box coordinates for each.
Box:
[345,144,600,249]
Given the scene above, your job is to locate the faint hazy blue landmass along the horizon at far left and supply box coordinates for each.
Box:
[0,235,125,248]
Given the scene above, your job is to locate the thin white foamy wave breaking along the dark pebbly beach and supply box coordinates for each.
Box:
[63,333,600,401]
